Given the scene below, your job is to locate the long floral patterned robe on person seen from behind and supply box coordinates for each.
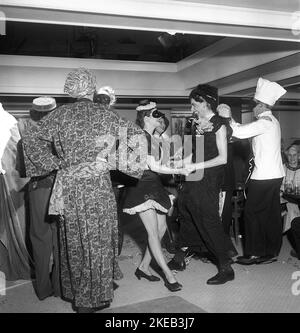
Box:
[23,99,145,307]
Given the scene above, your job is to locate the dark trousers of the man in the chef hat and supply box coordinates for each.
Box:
[244,178,282,256]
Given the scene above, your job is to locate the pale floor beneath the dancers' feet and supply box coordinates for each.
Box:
[0,214,300,313]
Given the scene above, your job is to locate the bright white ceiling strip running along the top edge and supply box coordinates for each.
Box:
[1,0,293,29]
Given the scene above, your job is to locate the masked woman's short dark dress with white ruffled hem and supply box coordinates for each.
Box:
[123,131,175,215]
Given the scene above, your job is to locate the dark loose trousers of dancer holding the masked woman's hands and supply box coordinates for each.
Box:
[178,173,232,266]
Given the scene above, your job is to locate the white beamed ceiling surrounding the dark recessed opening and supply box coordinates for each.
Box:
[0,0,300,100]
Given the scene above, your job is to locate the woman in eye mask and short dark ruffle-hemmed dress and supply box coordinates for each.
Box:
[123,100,189,291]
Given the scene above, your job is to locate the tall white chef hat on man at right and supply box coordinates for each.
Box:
[254,77,286,106]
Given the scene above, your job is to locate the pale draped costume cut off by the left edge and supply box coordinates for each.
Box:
[0,114,32,280]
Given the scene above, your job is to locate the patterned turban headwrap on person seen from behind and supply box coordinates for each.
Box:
[64,68,96,98]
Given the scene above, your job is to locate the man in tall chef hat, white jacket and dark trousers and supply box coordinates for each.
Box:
[231,78,286,265]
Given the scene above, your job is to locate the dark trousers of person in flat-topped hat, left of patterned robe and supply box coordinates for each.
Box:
[29,188,60,299]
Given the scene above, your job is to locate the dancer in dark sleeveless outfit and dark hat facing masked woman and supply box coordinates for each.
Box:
[181,85,235,285]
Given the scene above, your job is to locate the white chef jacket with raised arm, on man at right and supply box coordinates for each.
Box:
[231,110,285,180]
